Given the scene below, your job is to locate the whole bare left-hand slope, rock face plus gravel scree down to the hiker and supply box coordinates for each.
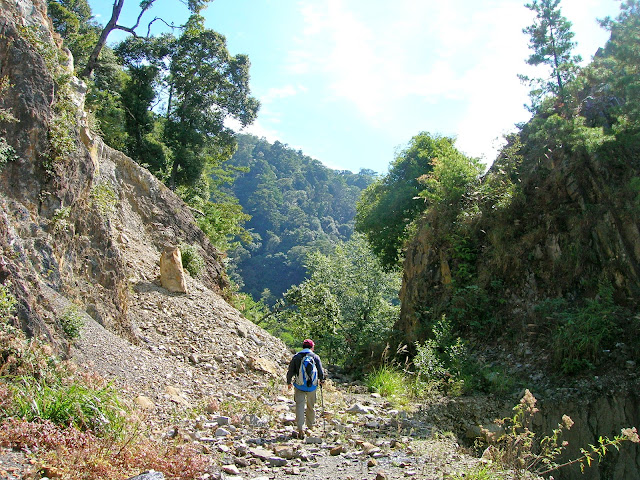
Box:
[0,0,288,412]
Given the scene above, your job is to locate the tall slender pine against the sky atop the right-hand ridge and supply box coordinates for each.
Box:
[519,0,582,111]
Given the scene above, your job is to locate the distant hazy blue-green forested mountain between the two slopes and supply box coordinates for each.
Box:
[227,135,375,303]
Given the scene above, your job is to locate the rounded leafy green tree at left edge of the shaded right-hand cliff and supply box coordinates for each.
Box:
[356,132,464,268]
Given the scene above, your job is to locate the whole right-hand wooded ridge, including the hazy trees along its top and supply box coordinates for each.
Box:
[398,1,640,382]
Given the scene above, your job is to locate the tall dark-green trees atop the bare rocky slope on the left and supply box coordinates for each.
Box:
[45,0,259,258]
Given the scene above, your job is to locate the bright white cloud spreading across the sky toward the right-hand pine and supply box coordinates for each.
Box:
[273,0,615,167]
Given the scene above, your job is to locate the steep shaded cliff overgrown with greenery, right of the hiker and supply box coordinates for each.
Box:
[397,50,640,479]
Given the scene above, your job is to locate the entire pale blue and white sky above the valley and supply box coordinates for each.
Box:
[89,0,620,173]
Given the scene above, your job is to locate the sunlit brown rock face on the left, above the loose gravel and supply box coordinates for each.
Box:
[0,0,228,343]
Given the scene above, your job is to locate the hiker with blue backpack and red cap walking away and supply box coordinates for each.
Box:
[287,338,325,438]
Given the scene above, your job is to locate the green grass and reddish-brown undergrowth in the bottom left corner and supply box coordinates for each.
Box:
[0,285,209,480]
